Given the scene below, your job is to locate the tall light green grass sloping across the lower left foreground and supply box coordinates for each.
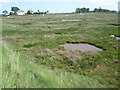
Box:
[0,41,107,88]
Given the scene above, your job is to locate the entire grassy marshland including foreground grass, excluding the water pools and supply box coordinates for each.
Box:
[1,13,119,88]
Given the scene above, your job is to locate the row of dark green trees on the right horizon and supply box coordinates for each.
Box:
[75,7,116,13]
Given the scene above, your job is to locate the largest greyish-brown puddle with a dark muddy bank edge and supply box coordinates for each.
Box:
[62,43,105,51]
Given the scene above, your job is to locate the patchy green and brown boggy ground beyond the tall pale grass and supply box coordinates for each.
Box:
[2,13,119,87]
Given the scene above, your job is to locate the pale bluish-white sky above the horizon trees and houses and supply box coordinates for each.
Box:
[0,0,120,13]
